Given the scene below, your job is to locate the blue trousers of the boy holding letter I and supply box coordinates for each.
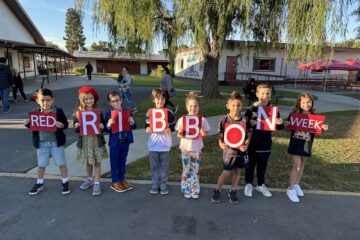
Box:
[110,143,129,183]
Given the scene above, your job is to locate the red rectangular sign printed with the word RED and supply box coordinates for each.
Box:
[29,112,57,132]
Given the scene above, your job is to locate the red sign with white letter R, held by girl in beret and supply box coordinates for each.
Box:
[79,111,101,136]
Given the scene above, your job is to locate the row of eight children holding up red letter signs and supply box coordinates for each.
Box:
[25,84,328,203]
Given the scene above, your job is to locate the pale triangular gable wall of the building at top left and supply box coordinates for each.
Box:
[0,0,35,44]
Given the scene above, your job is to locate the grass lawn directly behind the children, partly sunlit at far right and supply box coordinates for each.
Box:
[127,109,360,192]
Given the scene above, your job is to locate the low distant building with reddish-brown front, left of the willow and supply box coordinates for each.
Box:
[73,51,169,74]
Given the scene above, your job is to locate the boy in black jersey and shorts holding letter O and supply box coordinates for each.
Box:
[212,91,251,204]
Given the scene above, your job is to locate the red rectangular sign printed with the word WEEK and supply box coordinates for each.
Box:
[288,112,325,134]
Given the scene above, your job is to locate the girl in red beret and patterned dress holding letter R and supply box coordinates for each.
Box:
[74,86,108,196]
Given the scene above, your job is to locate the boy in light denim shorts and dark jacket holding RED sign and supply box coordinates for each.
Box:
[24,88,70,196]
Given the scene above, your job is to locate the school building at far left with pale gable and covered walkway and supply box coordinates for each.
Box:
[0,0,74,79]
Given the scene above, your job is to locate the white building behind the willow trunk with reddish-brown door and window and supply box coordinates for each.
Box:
[174,40,360,85]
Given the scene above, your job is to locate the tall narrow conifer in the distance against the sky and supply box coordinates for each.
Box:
[63,8,86,54]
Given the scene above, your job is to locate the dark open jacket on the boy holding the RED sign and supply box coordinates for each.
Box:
[25,107,69,148]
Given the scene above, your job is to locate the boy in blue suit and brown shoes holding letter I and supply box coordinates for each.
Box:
[105,91,136,192]
